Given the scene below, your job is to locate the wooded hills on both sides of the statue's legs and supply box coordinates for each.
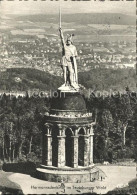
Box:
[0,68,136,91]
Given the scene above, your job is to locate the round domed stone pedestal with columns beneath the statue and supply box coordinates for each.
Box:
[37,92,99,182]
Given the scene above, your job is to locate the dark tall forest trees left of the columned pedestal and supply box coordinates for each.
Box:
[0,94,48,162]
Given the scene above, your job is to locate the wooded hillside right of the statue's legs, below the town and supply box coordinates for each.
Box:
[79,69,137,91]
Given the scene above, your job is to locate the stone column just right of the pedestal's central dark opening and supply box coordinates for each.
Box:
[72,136,78,168]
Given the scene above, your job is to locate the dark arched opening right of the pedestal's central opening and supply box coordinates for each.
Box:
[78,128,84,166]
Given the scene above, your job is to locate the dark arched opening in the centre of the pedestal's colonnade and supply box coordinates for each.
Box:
[65,128,72,167]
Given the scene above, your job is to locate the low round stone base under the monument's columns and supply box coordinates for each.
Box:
[36,165,99,183]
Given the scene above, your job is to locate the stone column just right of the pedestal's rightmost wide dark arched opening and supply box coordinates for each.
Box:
[84,135,89,166]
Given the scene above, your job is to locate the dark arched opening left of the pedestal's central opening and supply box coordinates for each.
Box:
[52,126,59,167]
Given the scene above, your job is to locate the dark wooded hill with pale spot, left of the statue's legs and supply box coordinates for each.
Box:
[0,68,62,91]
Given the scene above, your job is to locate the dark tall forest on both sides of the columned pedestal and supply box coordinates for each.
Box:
[0,89,137,163]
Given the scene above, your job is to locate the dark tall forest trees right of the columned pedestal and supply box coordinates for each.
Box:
[87,90,137,162]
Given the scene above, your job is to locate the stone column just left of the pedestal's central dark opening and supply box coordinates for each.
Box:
[57,136,66,167]
